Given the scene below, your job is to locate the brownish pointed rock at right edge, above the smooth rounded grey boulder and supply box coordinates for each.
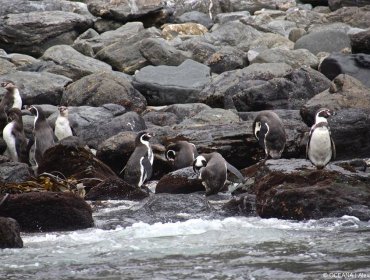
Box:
[325,5,370,28]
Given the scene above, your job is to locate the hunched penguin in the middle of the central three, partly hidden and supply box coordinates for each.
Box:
[165,141,198,170]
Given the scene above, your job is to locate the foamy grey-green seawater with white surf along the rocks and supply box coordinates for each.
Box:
[0,202,370,280]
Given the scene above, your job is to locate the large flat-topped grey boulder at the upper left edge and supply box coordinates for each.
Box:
[0,11,93,56]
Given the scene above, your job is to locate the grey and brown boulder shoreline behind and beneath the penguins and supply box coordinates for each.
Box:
[0,0,370,248]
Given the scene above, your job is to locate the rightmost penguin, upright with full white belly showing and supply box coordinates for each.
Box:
[306,108,336,169]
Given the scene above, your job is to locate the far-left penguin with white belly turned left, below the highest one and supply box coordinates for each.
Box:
[3,108,29,164]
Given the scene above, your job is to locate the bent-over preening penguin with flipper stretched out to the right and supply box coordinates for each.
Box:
[193,152,244,196]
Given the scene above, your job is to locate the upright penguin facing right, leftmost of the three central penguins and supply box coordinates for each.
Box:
[124,131,154,188]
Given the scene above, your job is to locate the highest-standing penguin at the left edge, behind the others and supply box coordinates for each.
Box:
[0,80,22,131]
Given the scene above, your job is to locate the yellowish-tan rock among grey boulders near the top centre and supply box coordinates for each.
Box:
[162,22,208,40]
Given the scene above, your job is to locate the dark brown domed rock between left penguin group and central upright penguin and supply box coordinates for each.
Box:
[38,144,116,187]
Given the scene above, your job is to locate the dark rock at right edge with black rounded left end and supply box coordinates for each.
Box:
[320,53,370,88]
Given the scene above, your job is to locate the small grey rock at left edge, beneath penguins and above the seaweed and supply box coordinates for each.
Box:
[0,162,33,183]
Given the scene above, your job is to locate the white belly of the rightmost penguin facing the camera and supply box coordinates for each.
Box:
[308,127,332,167]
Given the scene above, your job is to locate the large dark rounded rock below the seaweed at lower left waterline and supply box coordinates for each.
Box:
[0,192,94,232]
